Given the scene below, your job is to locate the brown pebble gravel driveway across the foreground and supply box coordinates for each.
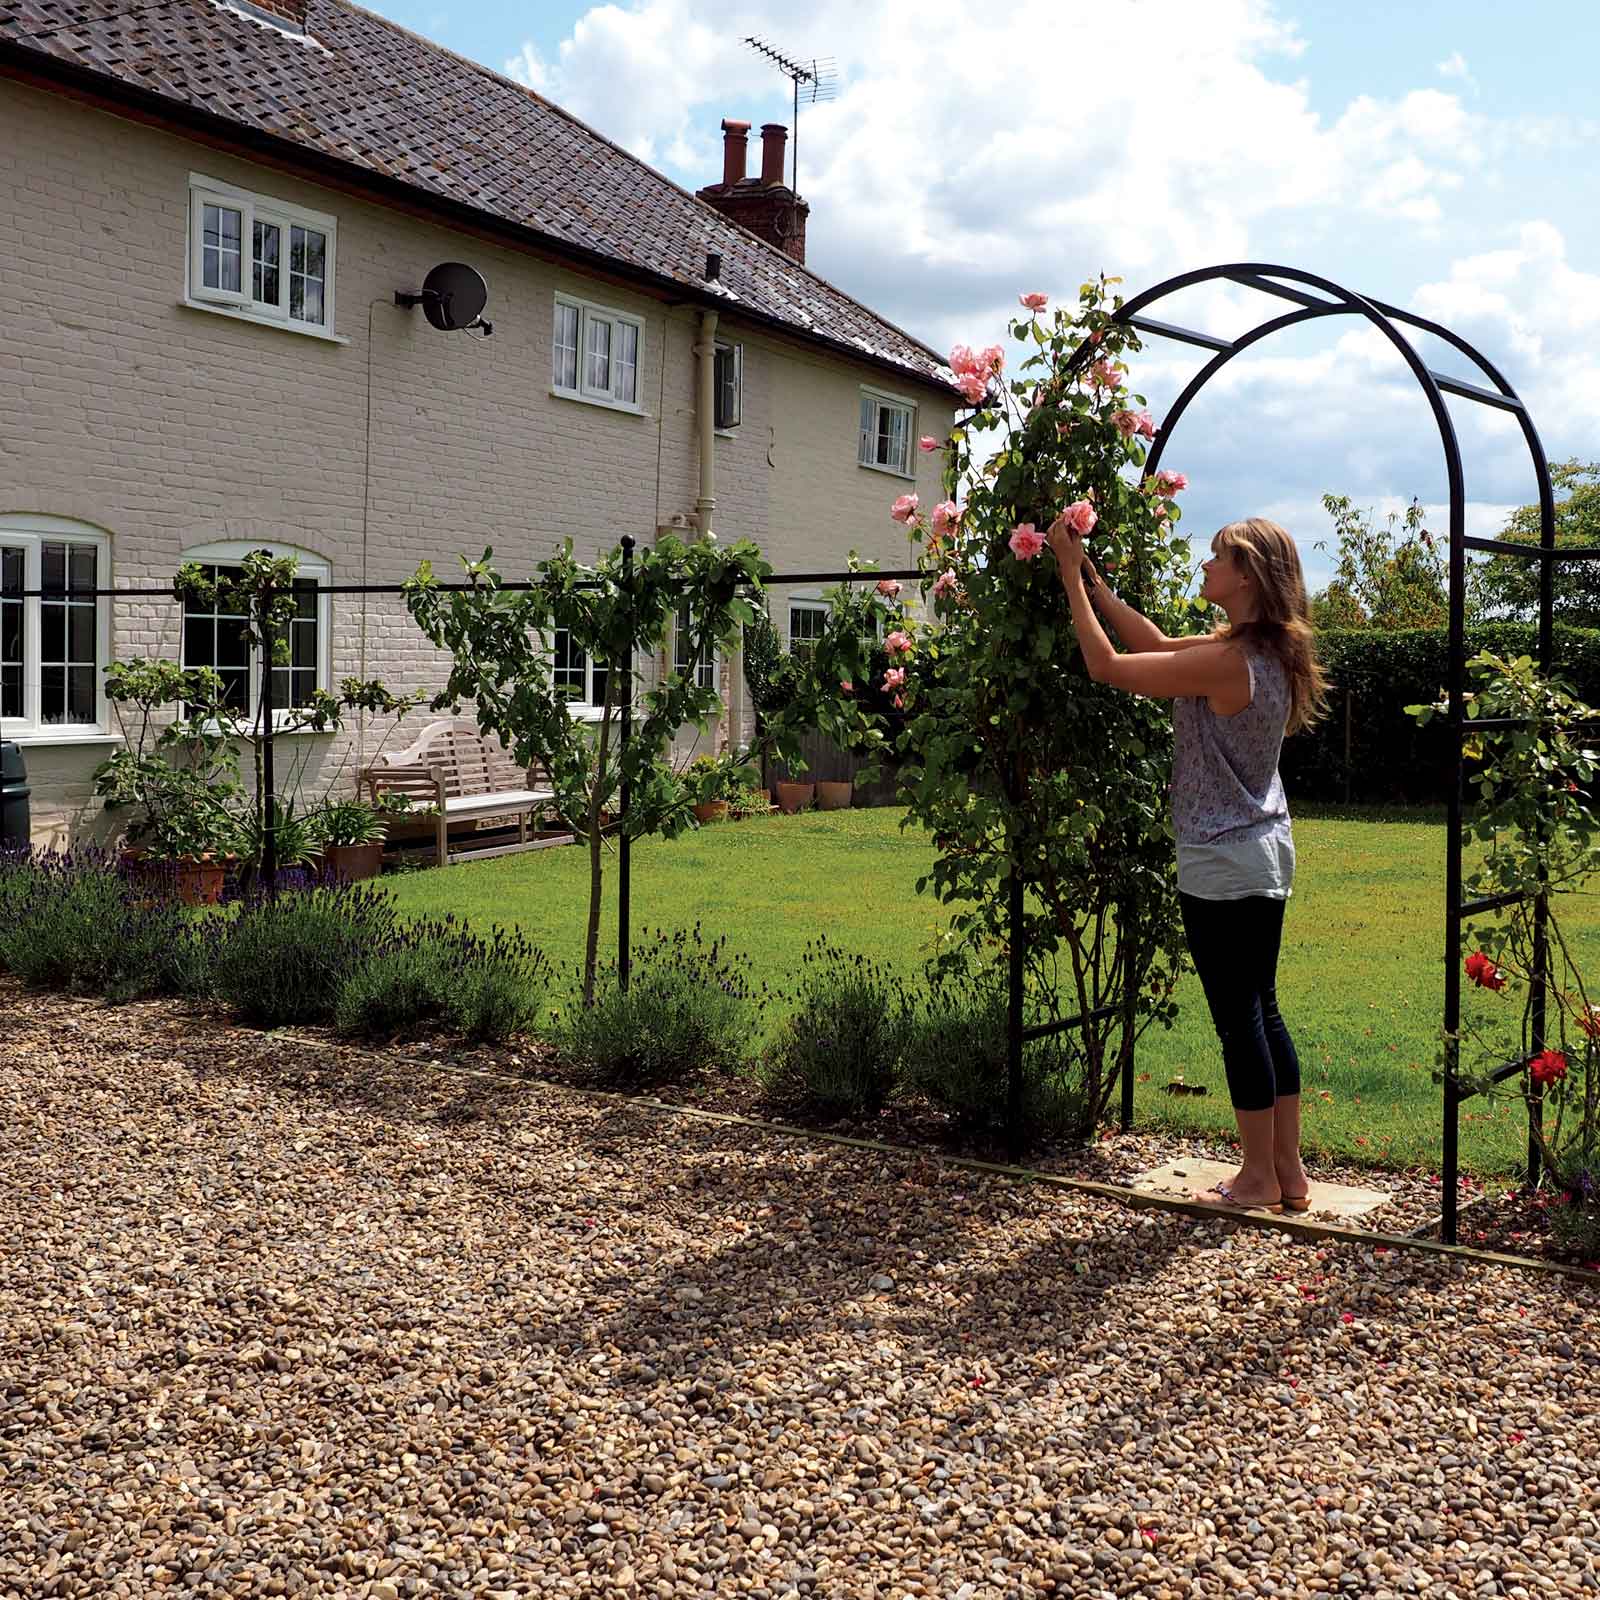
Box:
[0,990,1600,1600]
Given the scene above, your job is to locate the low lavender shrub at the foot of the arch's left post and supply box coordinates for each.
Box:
[904,979,1093,1142]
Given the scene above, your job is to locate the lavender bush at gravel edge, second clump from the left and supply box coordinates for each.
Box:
[211,883,395,1027]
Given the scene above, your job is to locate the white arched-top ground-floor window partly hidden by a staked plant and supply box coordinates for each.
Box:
[179,539,333,723]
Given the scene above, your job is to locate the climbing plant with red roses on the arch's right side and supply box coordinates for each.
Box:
[1406,651,1600,1258]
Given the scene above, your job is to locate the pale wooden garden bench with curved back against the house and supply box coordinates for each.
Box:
[362,722,555,867]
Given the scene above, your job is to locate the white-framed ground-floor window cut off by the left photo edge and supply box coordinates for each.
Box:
[0,514,110,739]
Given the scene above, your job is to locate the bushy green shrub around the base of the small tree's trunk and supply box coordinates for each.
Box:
[550,923,766,1086]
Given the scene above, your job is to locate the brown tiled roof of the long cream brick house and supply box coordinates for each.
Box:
[0,0,949,387]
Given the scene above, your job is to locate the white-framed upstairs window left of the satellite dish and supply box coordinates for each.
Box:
[186,173,338,336]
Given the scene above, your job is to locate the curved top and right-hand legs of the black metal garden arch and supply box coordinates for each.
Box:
[1117,262,1568,1245]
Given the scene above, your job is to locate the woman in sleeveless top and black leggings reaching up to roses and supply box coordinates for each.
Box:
[1050,517,1326,1211]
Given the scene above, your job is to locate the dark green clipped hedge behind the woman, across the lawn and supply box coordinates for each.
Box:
[1280,622,1600,808]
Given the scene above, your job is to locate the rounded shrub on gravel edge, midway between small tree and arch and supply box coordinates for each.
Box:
[762,938,912,1115]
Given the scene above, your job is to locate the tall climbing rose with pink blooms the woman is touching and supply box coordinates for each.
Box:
[882,277,1194,1134]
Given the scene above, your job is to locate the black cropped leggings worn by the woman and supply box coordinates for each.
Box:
[1178,894,1299,1110]
